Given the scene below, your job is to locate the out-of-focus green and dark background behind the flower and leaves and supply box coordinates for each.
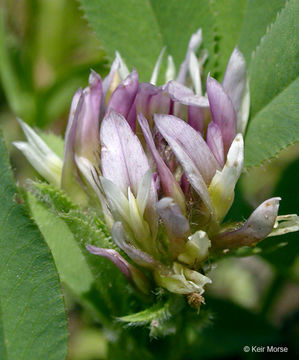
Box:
[0,0,299,360]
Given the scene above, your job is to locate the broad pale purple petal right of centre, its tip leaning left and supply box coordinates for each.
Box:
[154,115,220,213]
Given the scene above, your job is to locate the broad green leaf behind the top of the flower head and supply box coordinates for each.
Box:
[80,0,285,81]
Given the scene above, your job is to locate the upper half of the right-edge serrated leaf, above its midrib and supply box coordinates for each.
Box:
[249,0,299,116]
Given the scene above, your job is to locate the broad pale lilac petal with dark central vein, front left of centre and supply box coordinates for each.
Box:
[100,110,154,197]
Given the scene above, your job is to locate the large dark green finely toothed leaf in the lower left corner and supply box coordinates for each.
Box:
[0,133,67,360]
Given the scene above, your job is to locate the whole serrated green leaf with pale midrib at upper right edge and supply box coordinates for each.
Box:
[245,1,299,166]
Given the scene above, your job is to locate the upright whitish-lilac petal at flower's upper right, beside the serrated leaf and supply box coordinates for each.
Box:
[222,48,246,126]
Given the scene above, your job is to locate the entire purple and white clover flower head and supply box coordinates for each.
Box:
[16,30,299,304]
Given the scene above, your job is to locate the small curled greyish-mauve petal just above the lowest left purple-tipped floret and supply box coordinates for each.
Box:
[112,221,158,269]
